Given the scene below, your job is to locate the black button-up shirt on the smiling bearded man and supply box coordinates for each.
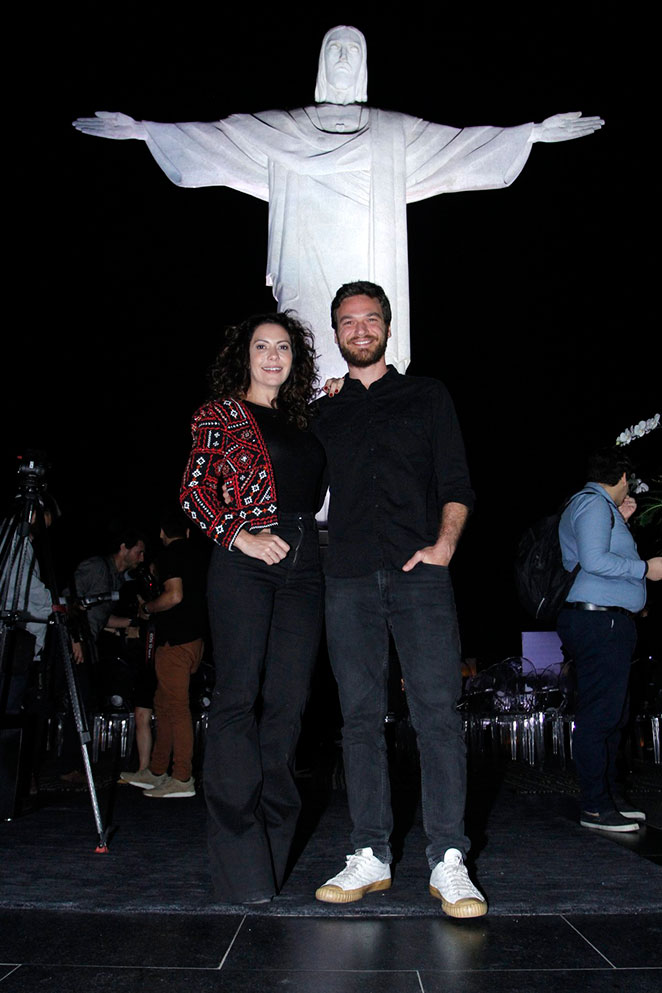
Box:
[312,366,474,577]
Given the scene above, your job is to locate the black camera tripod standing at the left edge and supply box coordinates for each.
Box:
[0,452,108,853]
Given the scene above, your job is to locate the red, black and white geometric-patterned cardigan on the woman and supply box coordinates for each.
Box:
[179,397,278,548]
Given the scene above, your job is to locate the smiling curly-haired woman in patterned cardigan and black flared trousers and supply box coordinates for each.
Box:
[181,312,325,903]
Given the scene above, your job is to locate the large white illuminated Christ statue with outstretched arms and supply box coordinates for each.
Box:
[74,25,604,382]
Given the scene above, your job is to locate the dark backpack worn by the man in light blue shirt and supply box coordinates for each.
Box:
[515,490,614,621]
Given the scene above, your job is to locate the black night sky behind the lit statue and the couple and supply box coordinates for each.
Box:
[0,2,662,659]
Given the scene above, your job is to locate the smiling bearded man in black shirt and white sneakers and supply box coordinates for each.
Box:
[314,282,487,917]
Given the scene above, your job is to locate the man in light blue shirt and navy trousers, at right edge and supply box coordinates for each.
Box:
[557,448,662,832]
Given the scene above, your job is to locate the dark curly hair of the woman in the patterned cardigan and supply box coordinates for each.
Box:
[209,310,318,429]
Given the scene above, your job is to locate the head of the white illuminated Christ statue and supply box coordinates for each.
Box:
[315,24,368,103]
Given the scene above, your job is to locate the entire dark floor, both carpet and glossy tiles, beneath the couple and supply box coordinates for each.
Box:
[0,762,662,993]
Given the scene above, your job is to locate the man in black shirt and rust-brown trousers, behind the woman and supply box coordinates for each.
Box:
[121,513,205,798]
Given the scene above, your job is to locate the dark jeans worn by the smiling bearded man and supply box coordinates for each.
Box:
[326,564,469,868]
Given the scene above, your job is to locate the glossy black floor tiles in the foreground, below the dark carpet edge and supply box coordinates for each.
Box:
[0,912,662,993]
